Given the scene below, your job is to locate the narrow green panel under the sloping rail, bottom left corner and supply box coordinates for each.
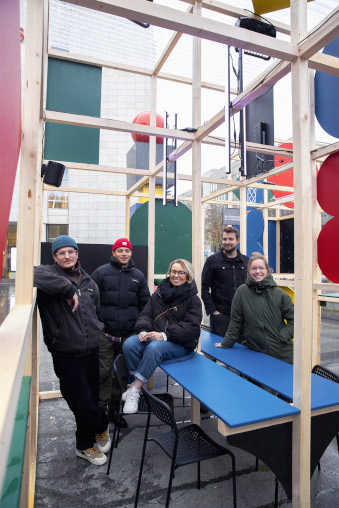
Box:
[0,376,31,508]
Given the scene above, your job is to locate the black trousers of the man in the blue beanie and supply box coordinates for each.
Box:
[52,348,108,450]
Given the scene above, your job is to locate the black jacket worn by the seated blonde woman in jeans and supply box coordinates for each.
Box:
[135,279,202,351]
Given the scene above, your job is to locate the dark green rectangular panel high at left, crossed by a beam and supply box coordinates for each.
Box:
[44,58,102,164]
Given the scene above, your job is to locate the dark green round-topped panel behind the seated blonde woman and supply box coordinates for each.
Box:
[130,200,192,273]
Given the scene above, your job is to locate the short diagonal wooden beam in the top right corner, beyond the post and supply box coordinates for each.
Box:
[298,6,339,59]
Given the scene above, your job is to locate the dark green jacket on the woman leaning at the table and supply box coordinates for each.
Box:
[221,274,294,363]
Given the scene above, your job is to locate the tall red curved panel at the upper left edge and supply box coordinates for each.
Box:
[0,0,21,270]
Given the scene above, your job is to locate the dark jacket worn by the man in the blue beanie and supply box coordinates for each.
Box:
[34,263,103,356]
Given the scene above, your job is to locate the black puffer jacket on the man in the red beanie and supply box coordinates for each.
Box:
[92,256,150,337]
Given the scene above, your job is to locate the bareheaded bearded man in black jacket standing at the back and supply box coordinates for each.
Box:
[201,226,249,337]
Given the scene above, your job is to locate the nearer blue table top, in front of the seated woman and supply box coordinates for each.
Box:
[160,353,300,428]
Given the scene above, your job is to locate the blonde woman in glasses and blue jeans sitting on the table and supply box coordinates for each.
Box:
[122,259,202,414]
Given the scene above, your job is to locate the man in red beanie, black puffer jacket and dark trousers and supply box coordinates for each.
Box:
[92,238,150,427]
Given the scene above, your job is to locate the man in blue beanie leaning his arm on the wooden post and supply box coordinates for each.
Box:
[34,235,111,466]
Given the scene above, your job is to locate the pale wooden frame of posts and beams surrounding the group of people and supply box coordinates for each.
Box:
[0,0,339,507]
